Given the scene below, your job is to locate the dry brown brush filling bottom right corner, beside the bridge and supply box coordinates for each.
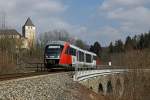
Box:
[106,70,150,100]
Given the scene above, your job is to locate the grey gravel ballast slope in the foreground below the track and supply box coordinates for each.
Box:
[0,73,102,100]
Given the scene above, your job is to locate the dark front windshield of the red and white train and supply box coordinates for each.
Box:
[45,45,63,58]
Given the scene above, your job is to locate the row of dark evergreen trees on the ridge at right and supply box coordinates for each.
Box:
[109,31,150,53]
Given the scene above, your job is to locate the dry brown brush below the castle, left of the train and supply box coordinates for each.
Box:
[0,49,43,74]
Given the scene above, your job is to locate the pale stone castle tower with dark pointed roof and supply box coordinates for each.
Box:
[22,18,36,48]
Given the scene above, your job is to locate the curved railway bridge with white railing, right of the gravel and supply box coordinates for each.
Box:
[73,69,129,96]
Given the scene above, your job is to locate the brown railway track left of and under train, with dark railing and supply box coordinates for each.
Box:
[0,63,75,81]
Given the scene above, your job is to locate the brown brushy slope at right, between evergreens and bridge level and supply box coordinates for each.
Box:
[111,49,150,68]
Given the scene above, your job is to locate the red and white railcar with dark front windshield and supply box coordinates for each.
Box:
[44,41,97,68]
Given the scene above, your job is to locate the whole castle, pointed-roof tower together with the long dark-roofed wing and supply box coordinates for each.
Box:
[0,18,36,49]
